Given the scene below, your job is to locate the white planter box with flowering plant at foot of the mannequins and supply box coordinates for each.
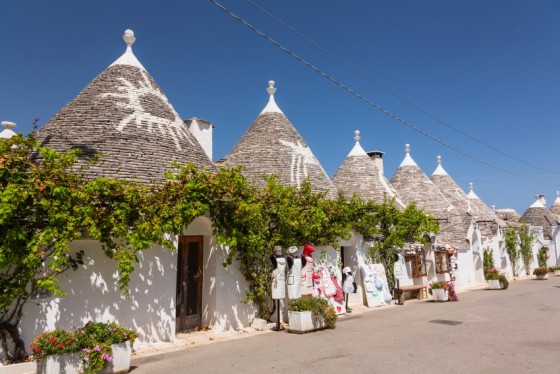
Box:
[288,296,337,333]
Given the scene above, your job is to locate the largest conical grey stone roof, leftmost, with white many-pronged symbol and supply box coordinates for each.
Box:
[38,30,214,183]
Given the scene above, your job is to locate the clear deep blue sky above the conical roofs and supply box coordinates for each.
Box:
[0,0,560,213]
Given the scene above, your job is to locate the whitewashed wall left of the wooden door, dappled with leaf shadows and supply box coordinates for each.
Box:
[21,240,176,352]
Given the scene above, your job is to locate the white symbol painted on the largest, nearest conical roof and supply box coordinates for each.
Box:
[100,71,192,150]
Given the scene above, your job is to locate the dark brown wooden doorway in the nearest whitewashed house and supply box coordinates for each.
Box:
[175,236,203,331]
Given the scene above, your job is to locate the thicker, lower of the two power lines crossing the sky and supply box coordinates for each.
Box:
[209,0,557,183]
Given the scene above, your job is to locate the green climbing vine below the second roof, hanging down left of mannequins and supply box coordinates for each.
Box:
[210,175,351,319]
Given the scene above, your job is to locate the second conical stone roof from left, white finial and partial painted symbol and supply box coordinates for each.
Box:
[218,81,337,198]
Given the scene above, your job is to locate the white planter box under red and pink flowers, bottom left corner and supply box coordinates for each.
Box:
[37,341,132,374]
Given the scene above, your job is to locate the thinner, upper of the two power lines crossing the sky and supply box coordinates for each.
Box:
[246,0,558,174]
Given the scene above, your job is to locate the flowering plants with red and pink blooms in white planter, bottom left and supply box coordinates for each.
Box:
[30,322,138,374]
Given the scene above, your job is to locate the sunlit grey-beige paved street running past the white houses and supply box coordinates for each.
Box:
[131,276,560,374]
